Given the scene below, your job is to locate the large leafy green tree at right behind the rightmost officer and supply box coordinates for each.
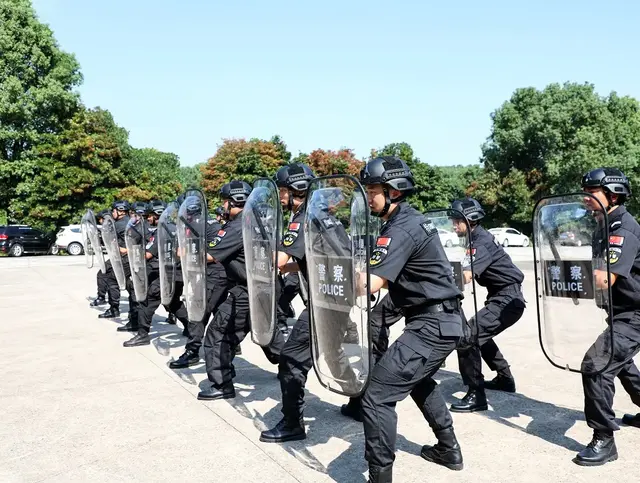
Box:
[482,83,640,207]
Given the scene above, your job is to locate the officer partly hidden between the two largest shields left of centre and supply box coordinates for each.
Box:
[260,163,315,443]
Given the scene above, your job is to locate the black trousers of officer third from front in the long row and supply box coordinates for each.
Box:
[204,285,284,388]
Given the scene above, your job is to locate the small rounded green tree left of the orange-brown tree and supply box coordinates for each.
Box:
[121,148,182,201]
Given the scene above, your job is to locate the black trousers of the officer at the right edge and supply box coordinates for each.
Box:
[582,311,640,431]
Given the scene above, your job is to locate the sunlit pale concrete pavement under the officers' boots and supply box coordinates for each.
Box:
[0,255,640,483]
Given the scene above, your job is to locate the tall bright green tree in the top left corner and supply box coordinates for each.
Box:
[0,0,82,217]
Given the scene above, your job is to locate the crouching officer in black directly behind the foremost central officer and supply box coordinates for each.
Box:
[451,198,526,412]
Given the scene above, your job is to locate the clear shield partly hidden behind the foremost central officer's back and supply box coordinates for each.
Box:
[425,208,478,349]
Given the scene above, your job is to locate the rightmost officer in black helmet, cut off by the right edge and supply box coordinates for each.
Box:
[574,168,640,466]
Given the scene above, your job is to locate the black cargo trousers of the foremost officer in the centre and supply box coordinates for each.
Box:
[362,311,462,466]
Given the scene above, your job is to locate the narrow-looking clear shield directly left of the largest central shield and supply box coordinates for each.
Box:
[242,178,282,347]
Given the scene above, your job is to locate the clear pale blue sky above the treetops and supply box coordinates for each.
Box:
[34,0,640,165]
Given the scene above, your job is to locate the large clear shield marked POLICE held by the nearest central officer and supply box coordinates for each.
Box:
[303,175,371,397]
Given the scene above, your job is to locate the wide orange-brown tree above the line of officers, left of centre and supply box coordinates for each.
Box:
[202,138,286,202]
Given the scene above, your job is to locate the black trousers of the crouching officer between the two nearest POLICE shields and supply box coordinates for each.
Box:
[458,285,526,389]
